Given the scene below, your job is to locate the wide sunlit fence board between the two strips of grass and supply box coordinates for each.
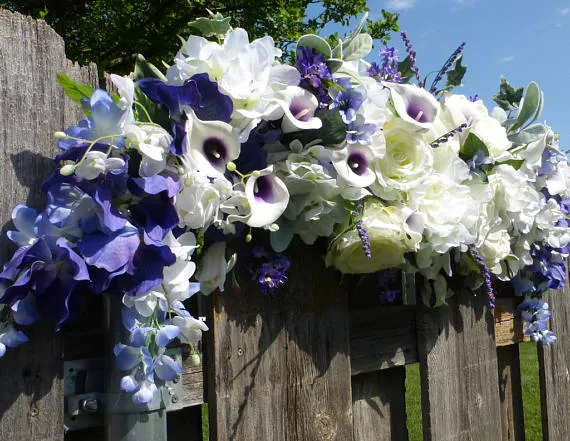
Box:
[417,292,501,441]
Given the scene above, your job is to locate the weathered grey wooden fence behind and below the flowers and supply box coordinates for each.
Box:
[0,11,570,441]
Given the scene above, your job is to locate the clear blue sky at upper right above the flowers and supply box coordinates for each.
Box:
[324,0,570,150]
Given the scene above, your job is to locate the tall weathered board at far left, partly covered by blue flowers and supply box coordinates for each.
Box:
[0,10,96,441]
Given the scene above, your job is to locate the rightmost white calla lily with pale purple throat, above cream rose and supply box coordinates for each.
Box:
[384,83,440,129]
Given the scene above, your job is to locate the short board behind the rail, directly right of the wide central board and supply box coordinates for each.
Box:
[352,366,408,441]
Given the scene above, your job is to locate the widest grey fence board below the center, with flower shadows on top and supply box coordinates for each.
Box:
[207,241,352,441]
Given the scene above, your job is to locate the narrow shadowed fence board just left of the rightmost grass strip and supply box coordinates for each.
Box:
[497,345,525,441]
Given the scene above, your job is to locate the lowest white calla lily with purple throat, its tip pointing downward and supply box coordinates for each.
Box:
[245,167,289,227]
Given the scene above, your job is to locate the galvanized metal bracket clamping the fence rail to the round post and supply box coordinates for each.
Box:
[63,348,183,430]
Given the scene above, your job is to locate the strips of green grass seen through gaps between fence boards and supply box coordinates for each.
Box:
[406,343,542,441]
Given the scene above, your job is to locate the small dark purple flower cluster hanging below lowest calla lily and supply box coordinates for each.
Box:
[249,245,291,293]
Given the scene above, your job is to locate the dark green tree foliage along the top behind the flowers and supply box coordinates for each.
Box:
[0,0,398,73]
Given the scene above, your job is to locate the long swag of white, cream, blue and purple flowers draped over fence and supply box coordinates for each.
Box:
[0,15,570,403]
